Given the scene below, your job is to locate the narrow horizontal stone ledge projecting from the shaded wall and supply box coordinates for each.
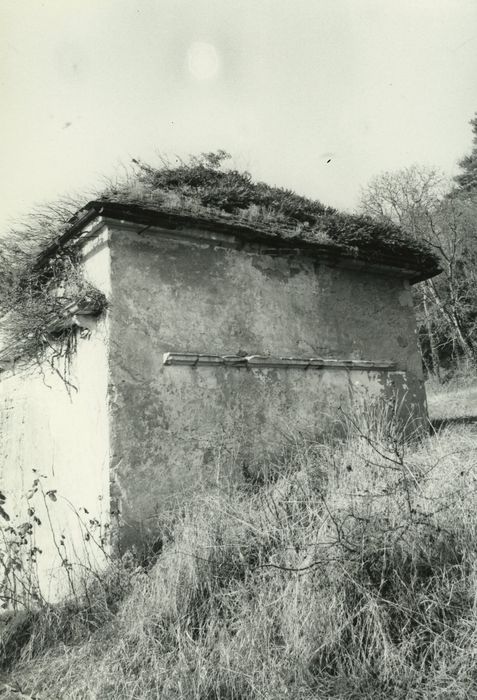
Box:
[163,352,396,371]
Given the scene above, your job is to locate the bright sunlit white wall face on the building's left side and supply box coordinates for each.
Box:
[0,230,110,600]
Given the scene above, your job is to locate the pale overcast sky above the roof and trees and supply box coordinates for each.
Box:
[0,0,477,228]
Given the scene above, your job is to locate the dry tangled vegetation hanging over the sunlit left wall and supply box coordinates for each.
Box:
[0,199,107,374]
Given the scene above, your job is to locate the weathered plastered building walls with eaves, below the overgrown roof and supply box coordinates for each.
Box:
[0,201,438,596]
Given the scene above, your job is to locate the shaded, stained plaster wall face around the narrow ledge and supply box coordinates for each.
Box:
[110,227,424,540]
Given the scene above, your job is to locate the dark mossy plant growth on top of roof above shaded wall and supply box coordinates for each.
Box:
[86,151,440,280]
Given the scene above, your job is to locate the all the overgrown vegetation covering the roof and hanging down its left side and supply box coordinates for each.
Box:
[0,150,437,370]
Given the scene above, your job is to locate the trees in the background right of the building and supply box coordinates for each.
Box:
[359,113,477,382]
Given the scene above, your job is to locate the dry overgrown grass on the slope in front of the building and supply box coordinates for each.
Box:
[0,388,477,700]
